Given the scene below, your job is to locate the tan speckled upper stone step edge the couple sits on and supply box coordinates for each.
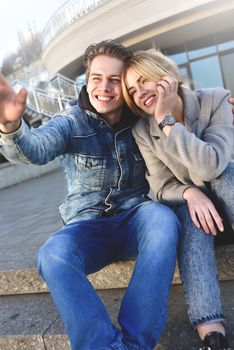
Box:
[0,245,234,295]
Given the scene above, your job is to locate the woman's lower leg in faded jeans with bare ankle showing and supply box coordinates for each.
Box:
[175,205,225,340]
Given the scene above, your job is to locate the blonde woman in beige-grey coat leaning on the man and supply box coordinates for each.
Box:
[123,50,234,350]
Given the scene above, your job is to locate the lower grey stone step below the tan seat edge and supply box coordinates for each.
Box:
[0,281,234,350]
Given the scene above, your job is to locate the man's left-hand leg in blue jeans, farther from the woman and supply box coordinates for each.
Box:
[38,219,127,350]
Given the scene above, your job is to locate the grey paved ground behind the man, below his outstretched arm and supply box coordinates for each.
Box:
[0,169,66,271]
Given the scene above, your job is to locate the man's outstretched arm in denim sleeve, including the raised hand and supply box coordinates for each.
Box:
[0,75,73,165]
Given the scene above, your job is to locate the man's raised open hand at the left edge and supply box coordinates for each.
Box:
[0,74,27,134]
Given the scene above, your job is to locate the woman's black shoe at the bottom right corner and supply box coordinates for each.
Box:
[200,332,231,350]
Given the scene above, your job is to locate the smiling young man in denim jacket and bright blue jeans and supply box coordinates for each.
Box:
[0,41,180,350]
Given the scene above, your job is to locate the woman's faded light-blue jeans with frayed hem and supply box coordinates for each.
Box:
[175,162,234,327]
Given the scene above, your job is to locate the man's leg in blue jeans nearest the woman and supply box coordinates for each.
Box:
[119,201,180,350]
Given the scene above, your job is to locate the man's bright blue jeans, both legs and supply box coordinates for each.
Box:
[38,201,180,350]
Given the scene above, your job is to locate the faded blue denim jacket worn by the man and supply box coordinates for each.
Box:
[0,92,149,223]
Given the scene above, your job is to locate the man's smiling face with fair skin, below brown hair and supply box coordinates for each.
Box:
[87,55,124,121]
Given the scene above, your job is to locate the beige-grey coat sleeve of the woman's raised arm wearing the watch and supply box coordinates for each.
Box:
[165,89,234,181]
